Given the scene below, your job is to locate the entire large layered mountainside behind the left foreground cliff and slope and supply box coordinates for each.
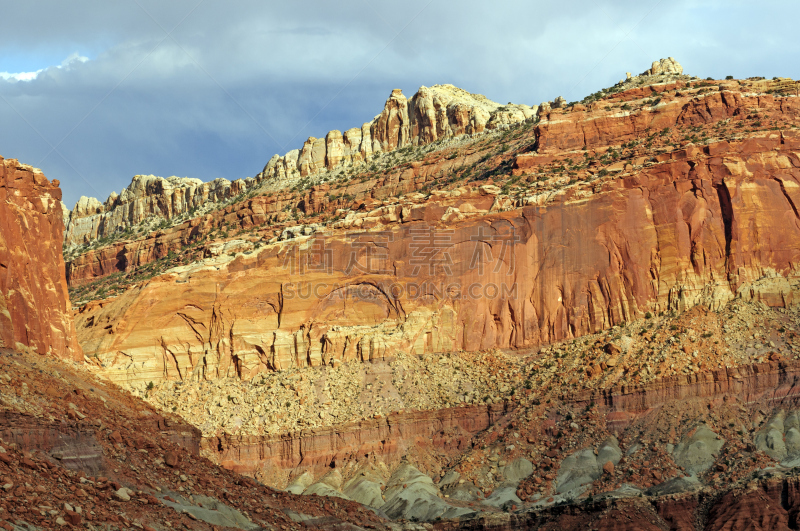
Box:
[54,58,800,529]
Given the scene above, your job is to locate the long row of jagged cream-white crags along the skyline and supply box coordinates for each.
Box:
[64,85,536,255]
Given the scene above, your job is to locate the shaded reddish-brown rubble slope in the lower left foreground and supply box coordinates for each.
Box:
[0,349,386,531]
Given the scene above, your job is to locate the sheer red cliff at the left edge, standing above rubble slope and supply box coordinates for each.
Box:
[0,157,81,359]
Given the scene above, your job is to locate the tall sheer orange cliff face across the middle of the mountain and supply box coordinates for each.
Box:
[77,127,800,386]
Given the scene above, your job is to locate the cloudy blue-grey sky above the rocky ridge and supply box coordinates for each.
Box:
[0,0,800,208]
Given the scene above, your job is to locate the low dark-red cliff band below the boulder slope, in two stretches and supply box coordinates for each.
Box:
[201,361,800,487]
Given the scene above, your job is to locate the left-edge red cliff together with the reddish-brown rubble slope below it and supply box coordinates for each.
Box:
[0,159,391,531]
